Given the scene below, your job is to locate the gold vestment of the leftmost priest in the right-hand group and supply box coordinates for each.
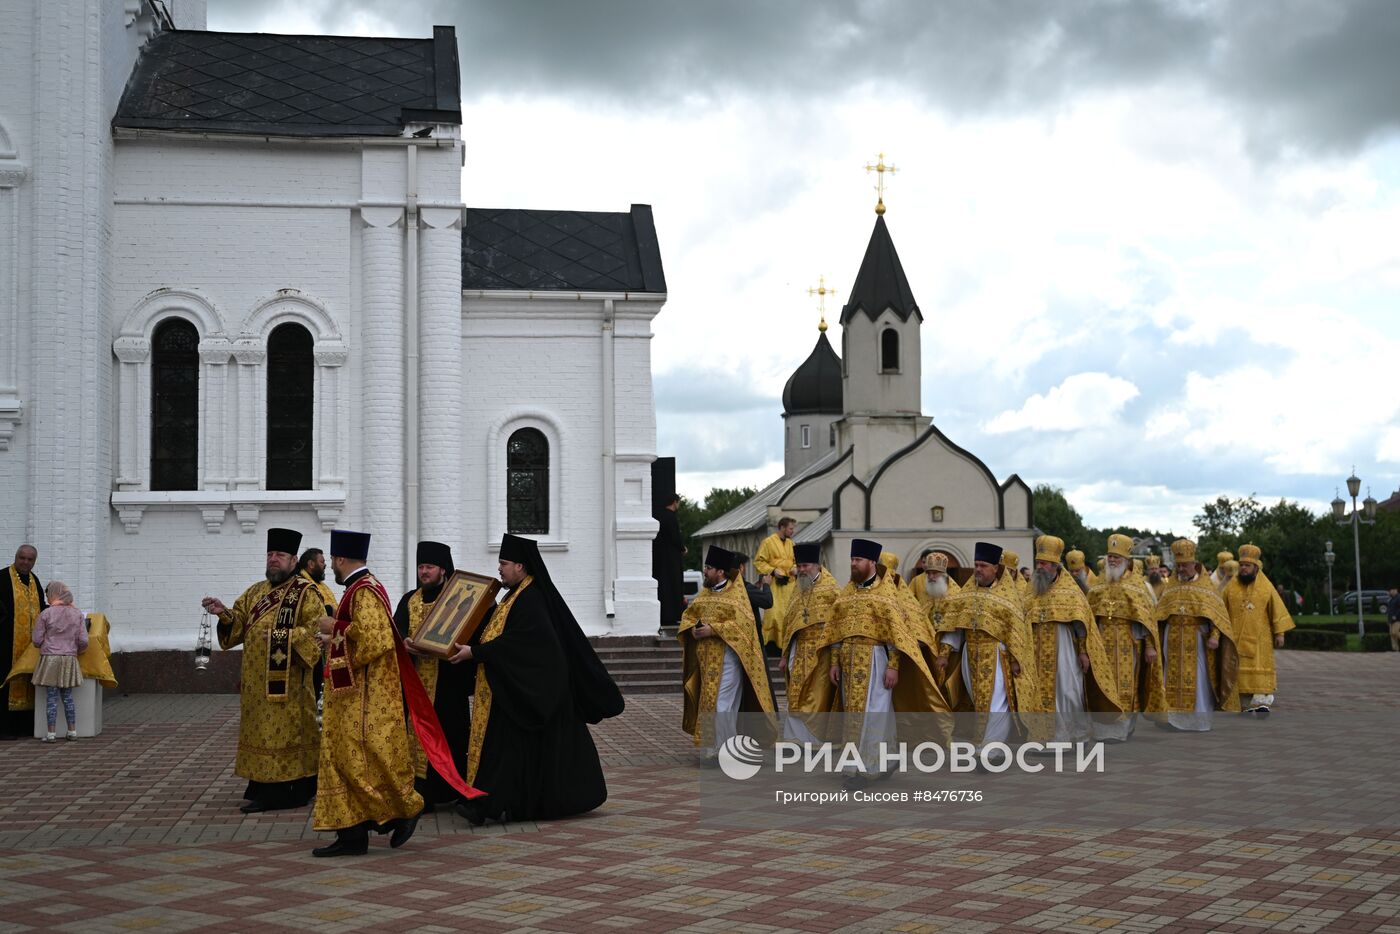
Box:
[676,580,777,746]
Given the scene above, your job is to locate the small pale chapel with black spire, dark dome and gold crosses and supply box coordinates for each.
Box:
[696,197,1037,580]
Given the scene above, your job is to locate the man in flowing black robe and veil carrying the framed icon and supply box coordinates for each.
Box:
[458,535,623,823]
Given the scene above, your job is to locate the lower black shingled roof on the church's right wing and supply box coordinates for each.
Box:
[462,204,666,293]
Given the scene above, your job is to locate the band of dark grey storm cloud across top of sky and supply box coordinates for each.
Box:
[210,0,1400,153]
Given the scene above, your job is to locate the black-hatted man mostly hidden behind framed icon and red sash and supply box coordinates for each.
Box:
[393,542,476,811]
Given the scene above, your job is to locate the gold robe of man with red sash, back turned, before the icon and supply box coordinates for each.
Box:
[312,576,423,830]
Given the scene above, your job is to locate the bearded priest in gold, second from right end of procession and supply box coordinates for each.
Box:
[1156,539,1239,732]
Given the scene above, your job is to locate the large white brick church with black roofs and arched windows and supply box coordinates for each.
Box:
[0,0,666,651]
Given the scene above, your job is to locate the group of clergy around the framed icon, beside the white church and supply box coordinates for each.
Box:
[193,529,623,857]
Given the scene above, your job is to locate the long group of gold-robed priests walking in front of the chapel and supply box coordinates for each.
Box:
[678,535,1294,788]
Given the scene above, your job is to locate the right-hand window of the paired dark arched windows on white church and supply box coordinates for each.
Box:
[267,323,316,490]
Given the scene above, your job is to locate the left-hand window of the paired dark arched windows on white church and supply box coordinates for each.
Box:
[151,318,199,490]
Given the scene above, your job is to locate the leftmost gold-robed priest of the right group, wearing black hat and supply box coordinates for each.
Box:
[676,545,777,759]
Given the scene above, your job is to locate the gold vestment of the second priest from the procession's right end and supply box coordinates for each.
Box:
[1156,574,1239,713]
